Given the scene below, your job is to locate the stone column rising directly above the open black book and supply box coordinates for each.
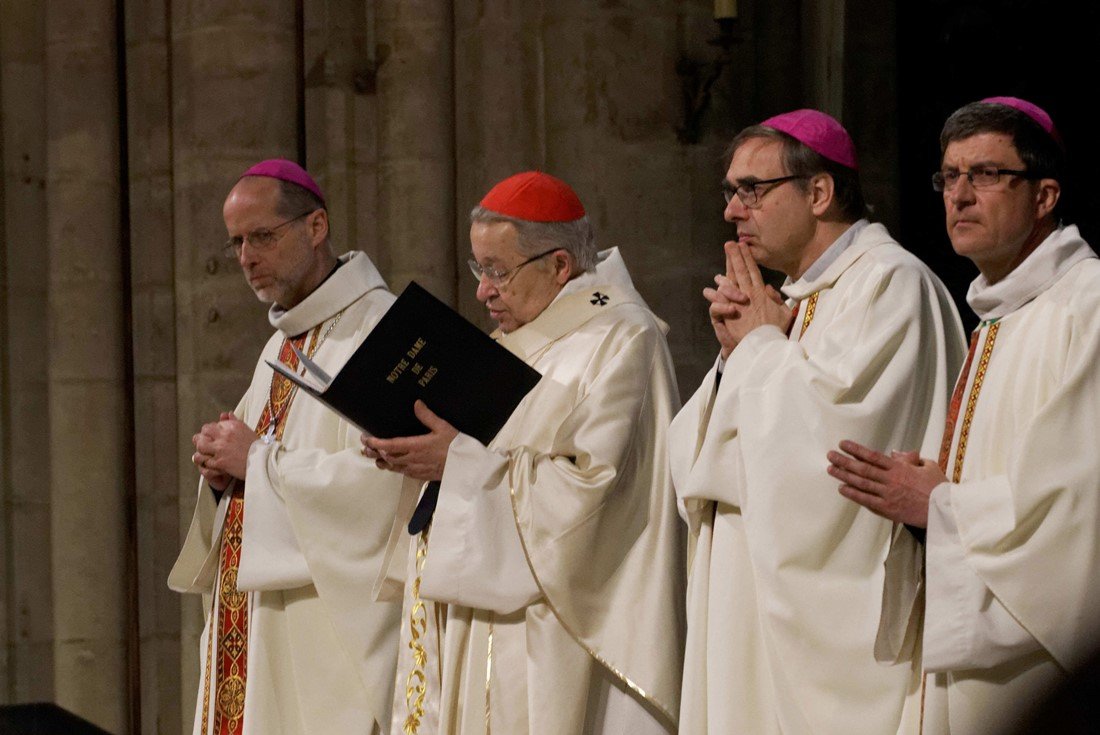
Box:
[376,0,457,304]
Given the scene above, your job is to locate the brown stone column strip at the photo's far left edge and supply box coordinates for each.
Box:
[0,0,54,702]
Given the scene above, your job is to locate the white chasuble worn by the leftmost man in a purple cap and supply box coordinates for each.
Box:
[168,253,400,735]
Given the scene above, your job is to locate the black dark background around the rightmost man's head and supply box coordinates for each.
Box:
[897,0,1100,328]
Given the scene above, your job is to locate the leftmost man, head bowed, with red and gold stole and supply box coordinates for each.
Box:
[168,162,400,735]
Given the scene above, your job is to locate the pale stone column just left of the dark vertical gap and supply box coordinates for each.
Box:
[46,0,130,732]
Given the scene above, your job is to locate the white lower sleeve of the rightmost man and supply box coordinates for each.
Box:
[924,483,1042,671]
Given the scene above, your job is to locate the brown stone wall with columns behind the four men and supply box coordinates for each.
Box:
[0,0,898,734]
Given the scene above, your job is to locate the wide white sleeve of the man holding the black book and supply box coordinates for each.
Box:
[420,434,541,614]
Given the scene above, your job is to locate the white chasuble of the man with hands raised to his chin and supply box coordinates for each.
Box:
[670,224,964,735]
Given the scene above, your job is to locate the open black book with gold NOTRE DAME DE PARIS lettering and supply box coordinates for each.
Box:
[267,282,542,445]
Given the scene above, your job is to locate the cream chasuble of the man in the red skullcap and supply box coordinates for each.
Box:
[382,250,684,735]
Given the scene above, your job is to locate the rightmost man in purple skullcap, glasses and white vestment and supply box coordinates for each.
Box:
[829,98,1100,735]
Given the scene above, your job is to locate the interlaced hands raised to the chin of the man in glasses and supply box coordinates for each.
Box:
[703,240,792,360]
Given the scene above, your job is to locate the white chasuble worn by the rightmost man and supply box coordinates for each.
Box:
[923,227,1100,735]
